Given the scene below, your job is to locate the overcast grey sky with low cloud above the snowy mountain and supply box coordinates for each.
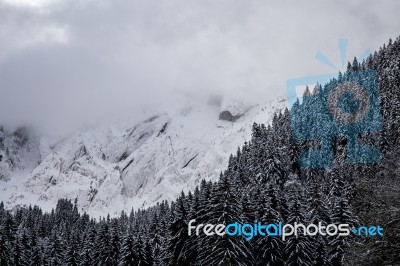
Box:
[0,0,400,129]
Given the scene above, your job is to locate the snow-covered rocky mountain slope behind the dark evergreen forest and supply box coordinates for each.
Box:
[0,98,286,217]
